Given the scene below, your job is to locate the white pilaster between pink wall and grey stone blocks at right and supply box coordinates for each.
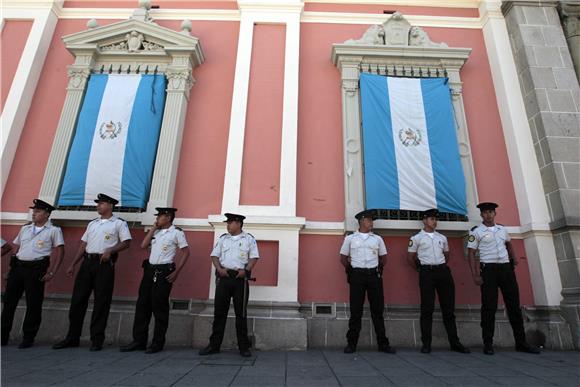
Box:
[480,0,562,306]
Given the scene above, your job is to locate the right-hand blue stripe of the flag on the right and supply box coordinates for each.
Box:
[421,78,467,215]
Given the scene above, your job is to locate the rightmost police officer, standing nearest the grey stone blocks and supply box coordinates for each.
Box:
[467,202,540,355]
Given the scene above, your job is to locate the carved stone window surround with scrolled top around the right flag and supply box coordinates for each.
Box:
[332,12,479,231]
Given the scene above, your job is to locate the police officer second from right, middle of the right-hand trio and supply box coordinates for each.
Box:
[407,209,470,353]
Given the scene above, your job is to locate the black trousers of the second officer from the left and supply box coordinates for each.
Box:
[67,254,117,345]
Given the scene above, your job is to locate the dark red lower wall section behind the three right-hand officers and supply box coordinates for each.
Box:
[298,235,534,305]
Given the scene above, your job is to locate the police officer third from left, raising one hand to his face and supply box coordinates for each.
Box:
[121,207,189,354]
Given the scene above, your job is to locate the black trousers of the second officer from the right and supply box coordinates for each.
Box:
[419,264,459,346]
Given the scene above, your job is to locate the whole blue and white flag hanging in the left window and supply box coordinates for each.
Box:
[58,74,166,208]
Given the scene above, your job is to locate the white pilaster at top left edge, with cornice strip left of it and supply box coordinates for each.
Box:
[0,0,61,196]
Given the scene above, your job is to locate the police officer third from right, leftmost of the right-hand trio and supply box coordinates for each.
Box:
[340,210,396,353]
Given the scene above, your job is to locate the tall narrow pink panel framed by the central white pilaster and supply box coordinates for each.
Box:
[240,24,286,206]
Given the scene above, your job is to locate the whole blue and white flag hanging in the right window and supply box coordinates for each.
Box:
[360,73,467,215]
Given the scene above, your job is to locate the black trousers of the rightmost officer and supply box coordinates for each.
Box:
[481,263,526,345]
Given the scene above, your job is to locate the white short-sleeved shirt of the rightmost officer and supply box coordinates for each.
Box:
[467,223,510,263]
